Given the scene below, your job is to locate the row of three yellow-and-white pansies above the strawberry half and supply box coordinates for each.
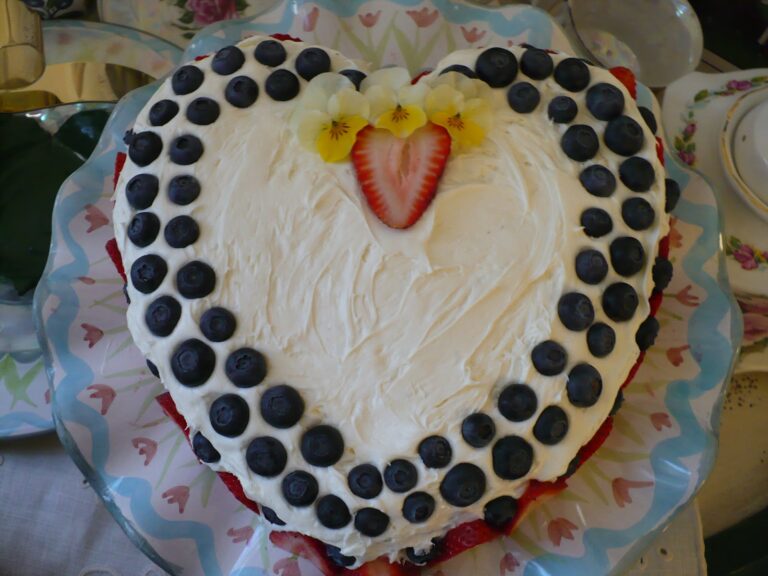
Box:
[292,68,491,162]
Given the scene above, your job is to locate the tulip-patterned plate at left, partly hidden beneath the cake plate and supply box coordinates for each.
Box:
[0,20,181,438]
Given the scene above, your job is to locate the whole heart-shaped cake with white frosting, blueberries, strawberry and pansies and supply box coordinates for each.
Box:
[114,37,676,566]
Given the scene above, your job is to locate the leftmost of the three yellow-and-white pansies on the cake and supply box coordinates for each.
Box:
[292,72,370,162]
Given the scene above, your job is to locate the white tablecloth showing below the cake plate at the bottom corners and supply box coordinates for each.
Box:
[0,434,706,576]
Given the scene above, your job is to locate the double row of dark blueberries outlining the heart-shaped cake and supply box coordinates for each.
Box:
[125,40,680,548]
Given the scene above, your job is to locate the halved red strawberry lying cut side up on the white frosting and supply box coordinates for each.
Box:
[352,123,451,228]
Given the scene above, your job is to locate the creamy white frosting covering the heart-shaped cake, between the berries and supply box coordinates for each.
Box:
[114,38,668,561]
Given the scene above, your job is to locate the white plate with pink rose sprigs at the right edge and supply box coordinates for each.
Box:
[662,69,768,372]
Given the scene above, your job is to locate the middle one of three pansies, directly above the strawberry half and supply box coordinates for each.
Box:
[360,68,429,138]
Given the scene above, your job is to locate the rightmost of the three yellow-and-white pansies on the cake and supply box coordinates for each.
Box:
[425,72,491,150]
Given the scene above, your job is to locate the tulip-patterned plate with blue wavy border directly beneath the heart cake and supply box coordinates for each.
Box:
[36,0,741,576]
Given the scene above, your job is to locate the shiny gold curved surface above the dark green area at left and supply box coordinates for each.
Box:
[0,62,154,112]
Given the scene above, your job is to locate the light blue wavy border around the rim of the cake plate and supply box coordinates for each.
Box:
[35,5,741,576]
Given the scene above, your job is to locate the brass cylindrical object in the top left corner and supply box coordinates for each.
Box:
[0,0,45,89]
